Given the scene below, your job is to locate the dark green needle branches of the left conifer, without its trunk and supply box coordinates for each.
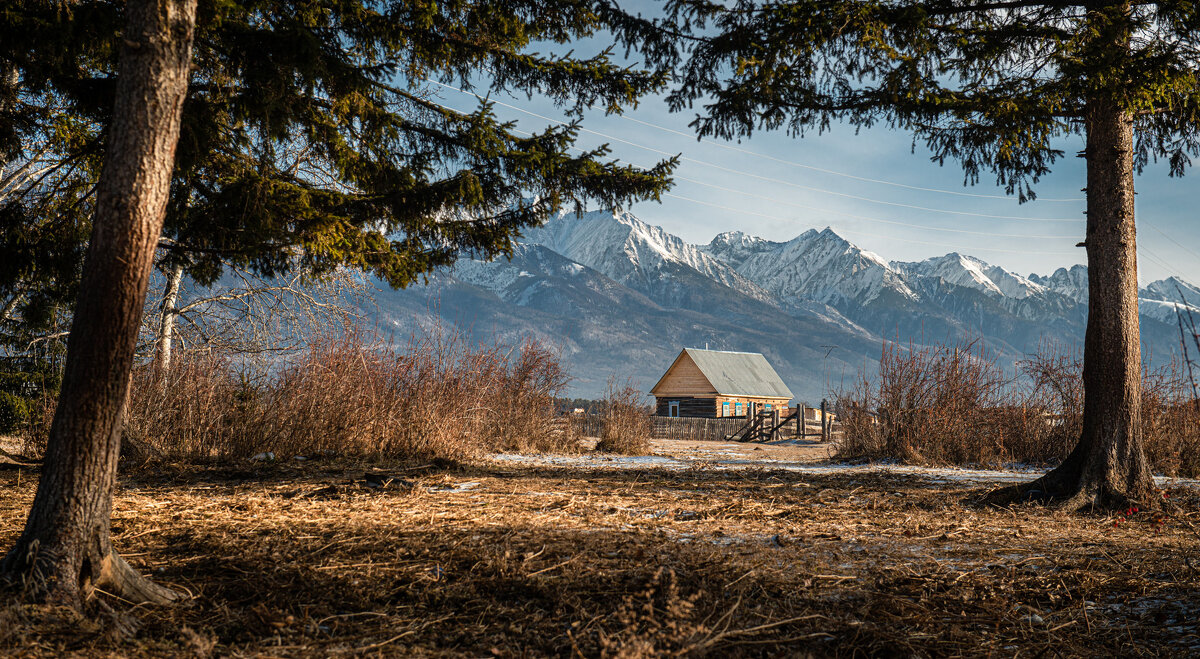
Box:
[0,0,672,295]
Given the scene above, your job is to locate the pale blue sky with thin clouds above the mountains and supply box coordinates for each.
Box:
[432,23,1200,286]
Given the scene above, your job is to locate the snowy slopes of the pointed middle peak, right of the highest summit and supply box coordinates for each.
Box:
[708,228,918,305]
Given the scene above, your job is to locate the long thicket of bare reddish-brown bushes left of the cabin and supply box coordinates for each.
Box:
[91,329,578,460]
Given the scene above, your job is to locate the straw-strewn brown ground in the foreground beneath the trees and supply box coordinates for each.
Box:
[0,443,1200,657]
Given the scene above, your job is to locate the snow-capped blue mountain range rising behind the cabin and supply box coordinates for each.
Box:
[367,211,1200,403]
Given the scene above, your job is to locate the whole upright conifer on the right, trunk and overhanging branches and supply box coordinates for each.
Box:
[662,0,1200,508]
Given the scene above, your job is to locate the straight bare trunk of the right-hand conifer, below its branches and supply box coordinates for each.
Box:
[1000,98,1153,509]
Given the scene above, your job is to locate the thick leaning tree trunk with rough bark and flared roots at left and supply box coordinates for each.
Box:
[0,0,196,607]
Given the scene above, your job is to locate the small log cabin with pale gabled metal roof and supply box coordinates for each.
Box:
[650,348,792,419]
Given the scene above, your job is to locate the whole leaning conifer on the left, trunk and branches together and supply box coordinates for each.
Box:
[0,0,673,606]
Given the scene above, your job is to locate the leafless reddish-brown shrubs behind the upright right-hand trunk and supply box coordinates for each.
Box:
[839,342,1200,477]
